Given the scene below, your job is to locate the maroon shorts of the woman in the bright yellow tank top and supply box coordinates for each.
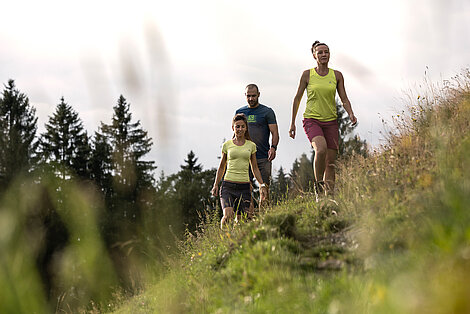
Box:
[302,118,339,150]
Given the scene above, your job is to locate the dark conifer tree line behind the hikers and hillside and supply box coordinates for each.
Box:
[0,80,367,306]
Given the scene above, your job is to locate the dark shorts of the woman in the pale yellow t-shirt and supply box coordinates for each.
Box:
[220,181,251,215]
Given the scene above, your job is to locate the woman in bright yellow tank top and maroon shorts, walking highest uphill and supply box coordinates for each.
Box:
[289,41,357,198]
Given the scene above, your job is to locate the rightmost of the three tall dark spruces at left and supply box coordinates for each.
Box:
[100,95,156,241]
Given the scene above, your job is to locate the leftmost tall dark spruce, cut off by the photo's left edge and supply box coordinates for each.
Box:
[0,80,37,190]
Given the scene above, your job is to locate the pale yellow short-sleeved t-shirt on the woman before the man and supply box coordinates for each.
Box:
[222,140,256,182]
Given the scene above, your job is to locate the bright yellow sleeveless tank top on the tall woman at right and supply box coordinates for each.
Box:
[304,69,338,122]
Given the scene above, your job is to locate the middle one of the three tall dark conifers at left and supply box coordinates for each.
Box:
[39,97,91,179]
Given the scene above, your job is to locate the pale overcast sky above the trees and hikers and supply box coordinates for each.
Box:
[0,0,470,175]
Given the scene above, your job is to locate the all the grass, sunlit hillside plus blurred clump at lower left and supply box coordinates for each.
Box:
[0,69,470,313]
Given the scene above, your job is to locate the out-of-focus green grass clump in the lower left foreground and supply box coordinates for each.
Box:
[0,176,117,313]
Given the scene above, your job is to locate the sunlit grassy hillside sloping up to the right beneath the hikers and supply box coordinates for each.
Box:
[111,70,470,313]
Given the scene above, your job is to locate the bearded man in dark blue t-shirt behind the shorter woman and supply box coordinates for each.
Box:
[236,84,279,207]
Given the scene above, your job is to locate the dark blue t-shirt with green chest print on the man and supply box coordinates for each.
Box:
[235,104,277,159]
